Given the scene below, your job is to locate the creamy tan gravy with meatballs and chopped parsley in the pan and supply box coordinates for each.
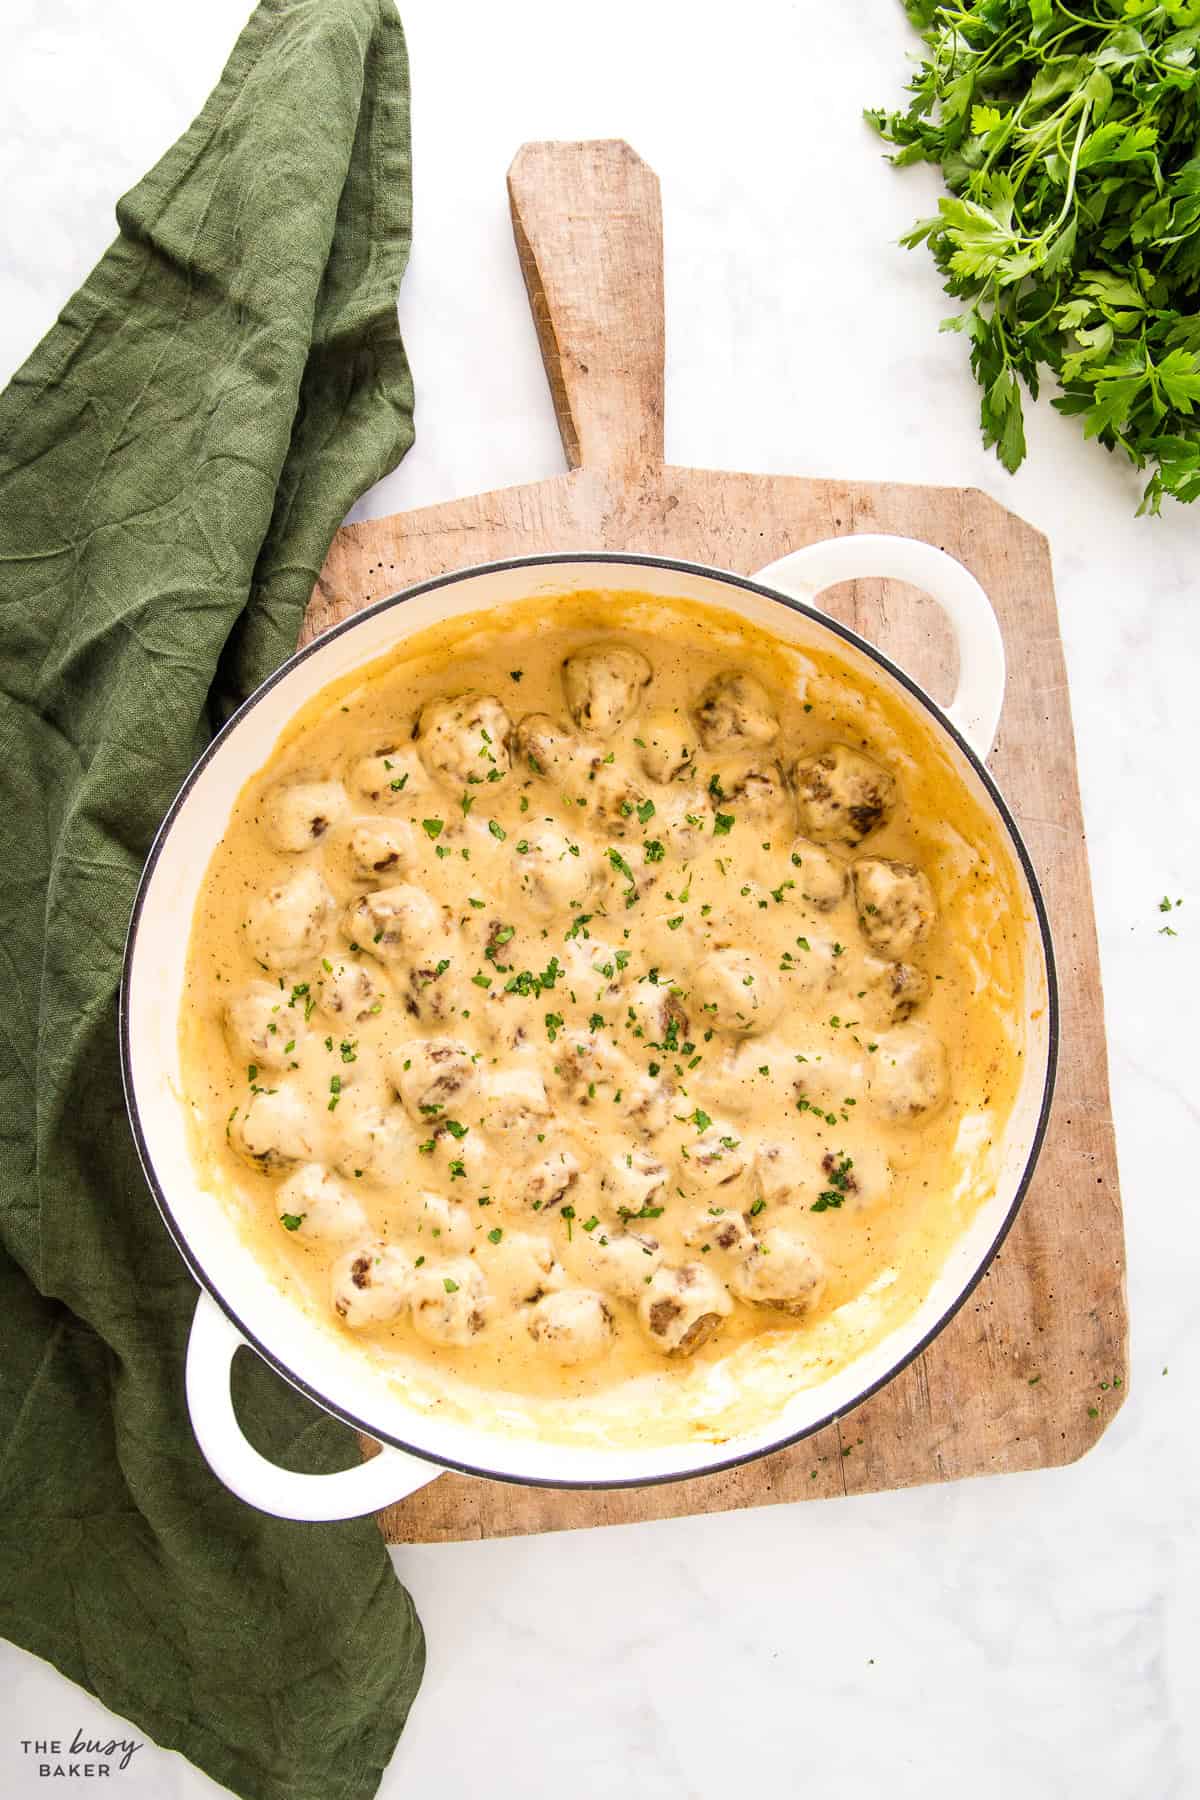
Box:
[180,594,1024,1436]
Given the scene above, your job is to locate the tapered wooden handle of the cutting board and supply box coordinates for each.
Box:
[509,139,666,475]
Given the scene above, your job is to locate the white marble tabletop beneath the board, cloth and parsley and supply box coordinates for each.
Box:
[0,0,1200,1800]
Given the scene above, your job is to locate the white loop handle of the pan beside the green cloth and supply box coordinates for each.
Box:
[187,1294,443,1519]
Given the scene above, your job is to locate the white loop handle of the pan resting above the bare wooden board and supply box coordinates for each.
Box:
[754,533,1004,761]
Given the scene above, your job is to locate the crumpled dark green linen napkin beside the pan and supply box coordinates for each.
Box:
[0,0,423,1800]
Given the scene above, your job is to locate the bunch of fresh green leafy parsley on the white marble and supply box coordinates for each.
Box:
[867,0,1200,513]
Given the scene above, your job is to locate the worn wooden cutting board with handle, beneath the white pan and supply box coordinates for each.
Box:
[304,142,1128,1543]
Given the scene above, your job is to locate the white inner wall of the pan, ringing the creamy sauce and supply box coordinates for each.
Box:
[126,556,1051,1510]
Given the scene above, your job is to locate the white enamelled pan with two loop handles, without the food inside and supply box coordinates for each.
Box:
[121,536,1058,1519]
